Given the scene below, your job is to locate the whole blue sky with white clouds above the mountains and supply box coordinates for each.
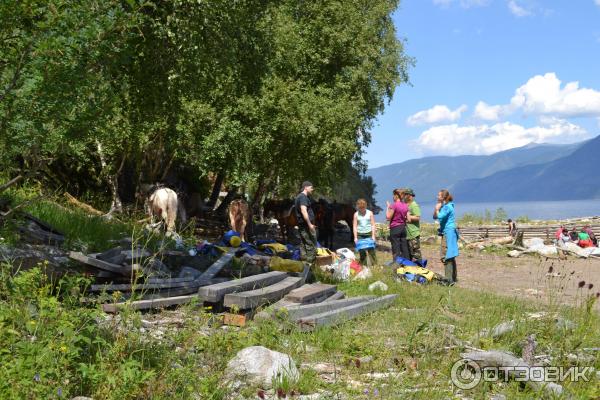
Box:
[365,0,600,168]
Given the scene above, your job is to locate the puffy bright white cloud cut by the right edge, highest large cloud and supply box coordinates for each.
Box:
[510,73,600,117]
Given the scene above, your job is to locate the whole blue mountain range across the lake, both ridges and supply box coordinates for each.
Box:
[367,136,600,206]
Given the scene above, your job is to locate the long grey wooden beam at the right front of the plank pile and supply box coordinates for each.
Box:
[297,294,398,331]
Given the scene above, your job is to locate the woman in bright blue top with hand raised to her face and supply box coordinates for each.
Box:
[433,189,458,285]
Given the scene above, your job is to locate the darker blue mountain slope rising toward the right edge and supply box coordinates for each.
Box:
[454,136,600,202]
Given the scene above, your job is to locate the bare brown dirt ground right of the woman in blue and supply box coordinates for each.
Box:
[423,246,600,311]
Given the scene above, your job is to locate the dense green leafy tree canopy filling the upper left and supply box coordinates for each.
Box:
[0,0,412,205]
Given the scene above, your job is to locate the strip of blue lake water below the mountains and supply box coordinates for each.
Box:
[375,200,600,222]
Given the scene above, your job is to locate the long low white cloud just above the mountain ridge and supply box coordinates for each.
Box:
[416,119,589,155]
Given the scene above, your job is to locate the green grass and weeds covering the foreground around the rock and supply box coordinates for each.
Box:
[0,195,600,400]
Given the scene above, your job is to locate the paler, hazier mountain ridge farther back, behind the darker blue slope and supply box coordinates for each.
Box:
[367,142,585,206]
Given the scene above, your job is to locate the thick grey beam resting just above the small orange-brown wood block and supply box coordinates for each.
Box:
[223,276,302,310]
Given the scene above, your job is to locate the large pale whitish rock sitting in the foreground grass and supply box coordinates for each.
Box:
[225,346,300,388]
